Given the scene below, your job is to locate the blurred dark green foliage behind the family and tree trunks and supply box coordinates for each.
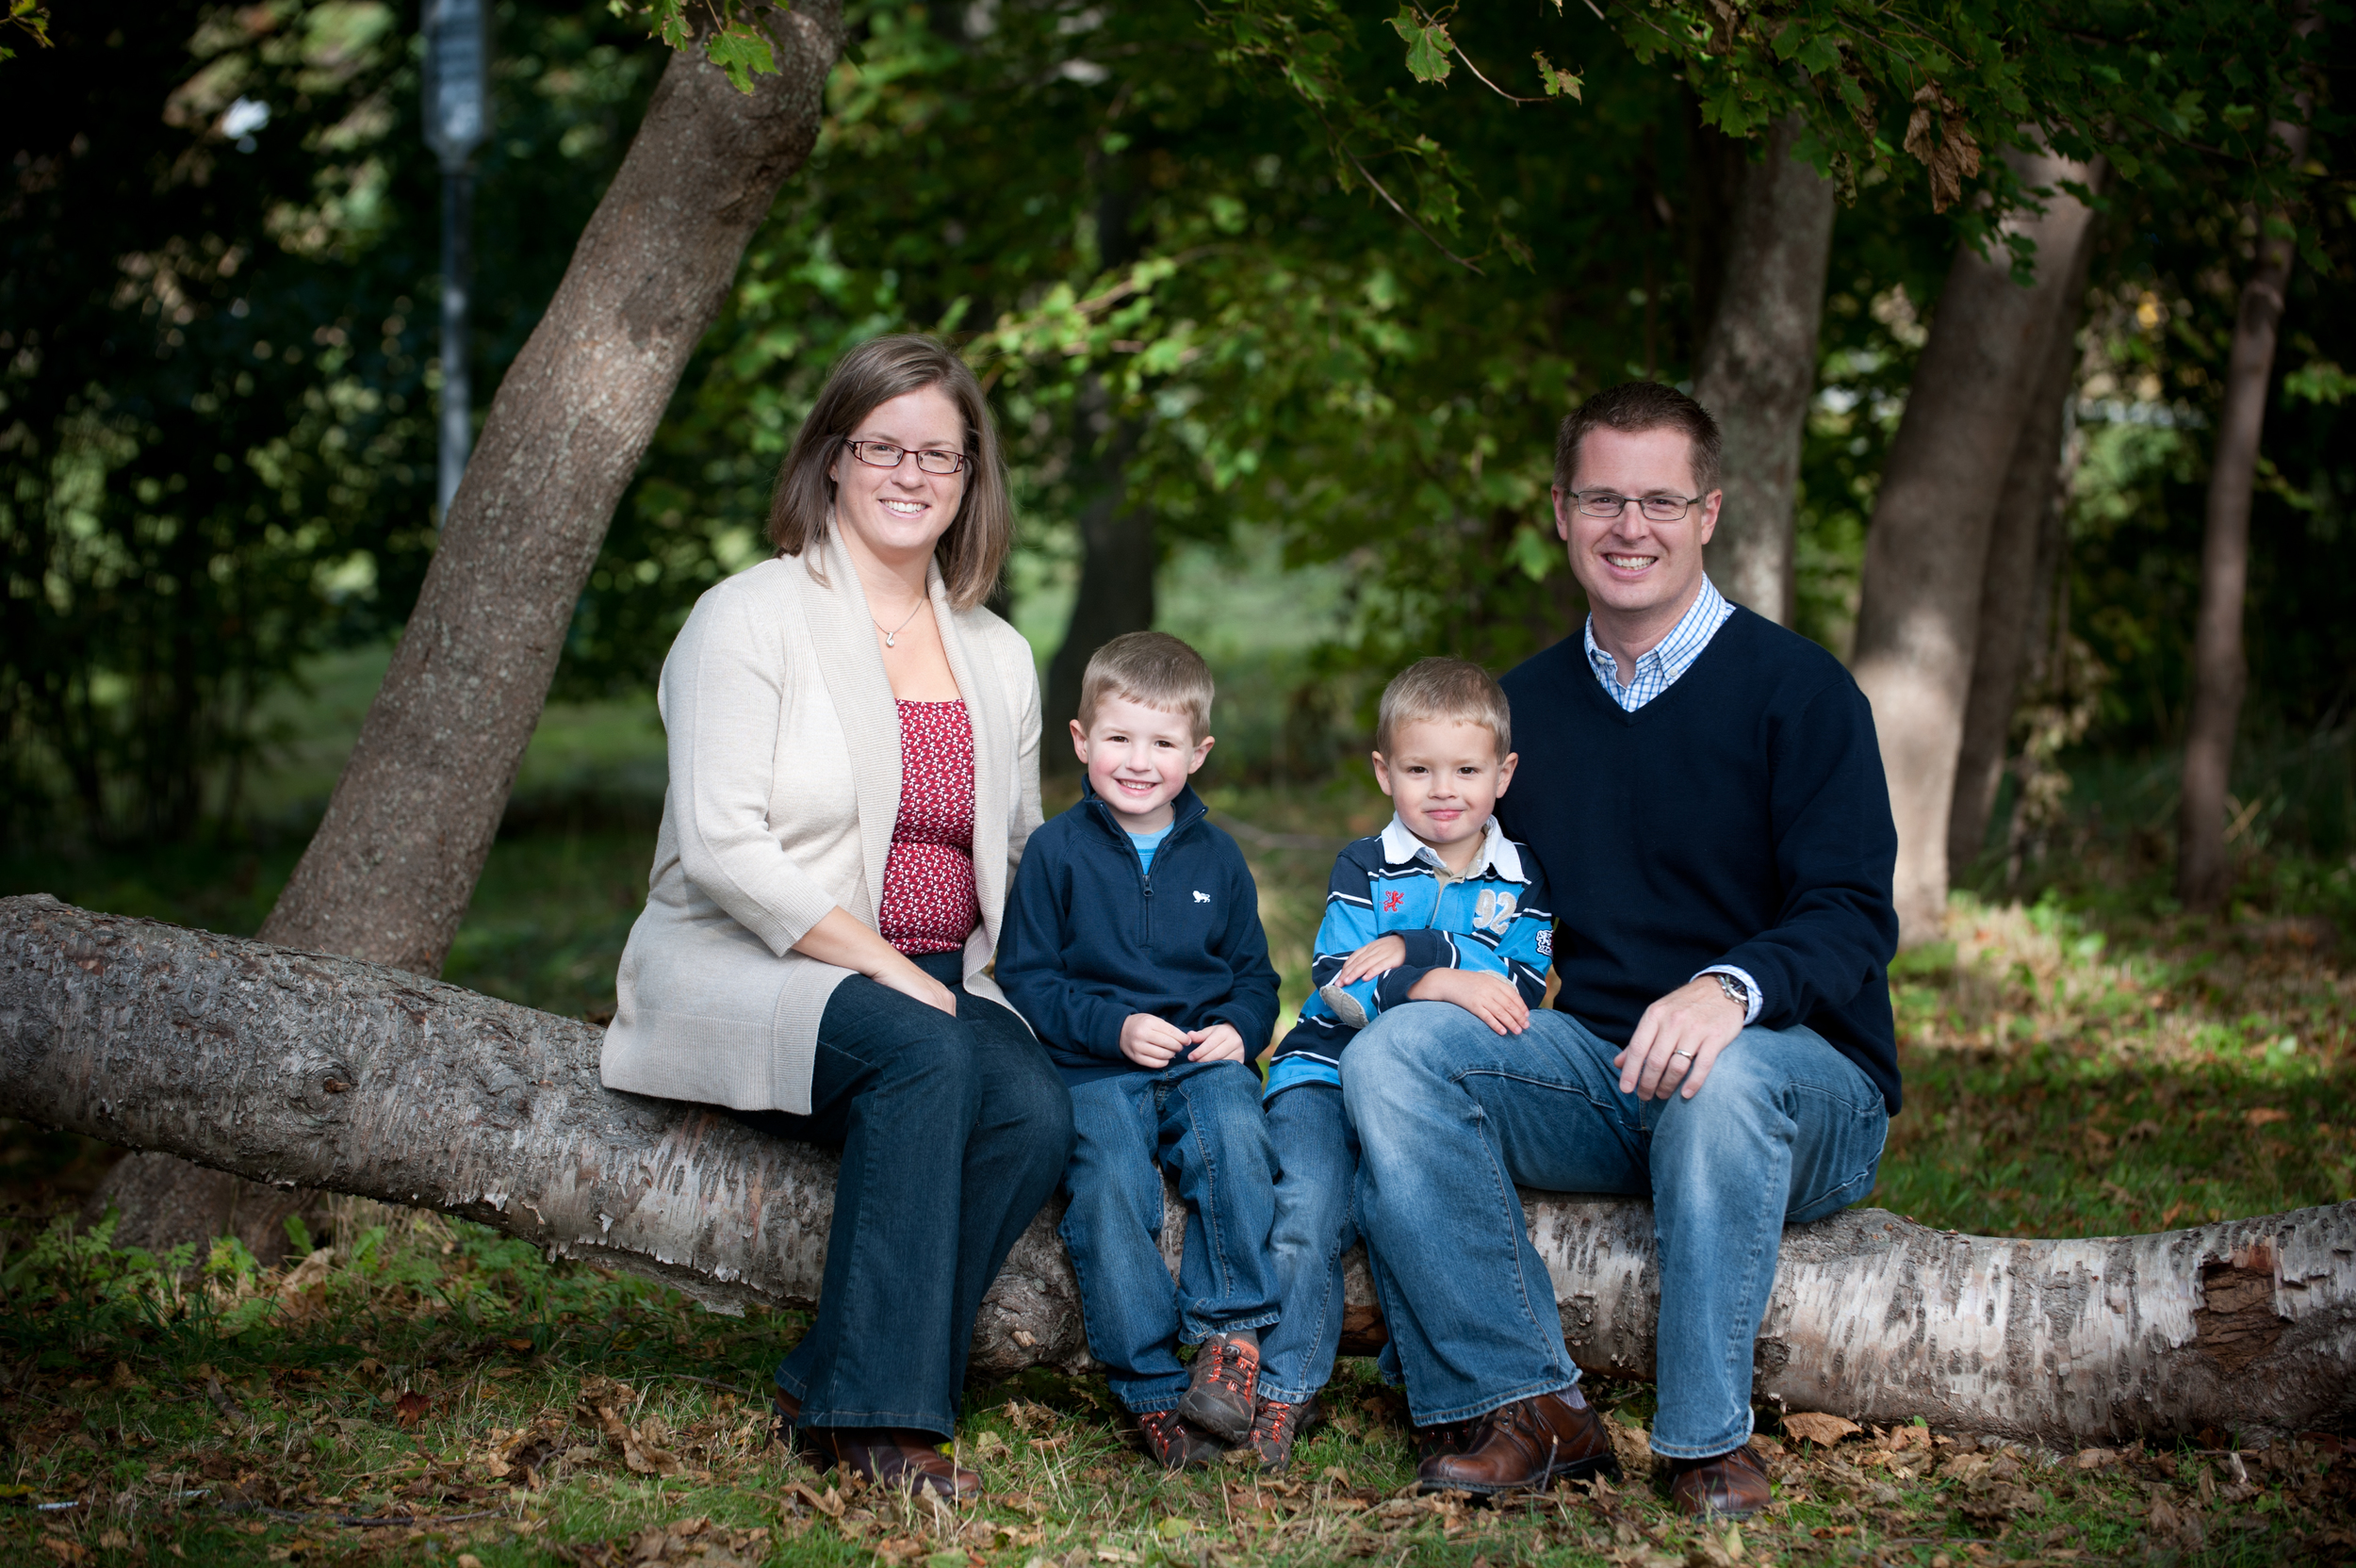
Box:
[0,0,2356,890]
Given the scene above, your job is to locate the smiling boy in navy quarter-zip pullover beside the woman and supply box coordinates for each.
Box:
[997,631,1277,1469]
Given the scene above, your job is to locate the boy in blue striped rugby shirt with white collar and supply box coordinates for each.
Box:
[1253,660,1555,1467]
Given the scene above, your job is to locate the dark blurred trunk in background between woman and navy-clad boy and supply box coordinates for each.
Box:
[1039,164,1162,753]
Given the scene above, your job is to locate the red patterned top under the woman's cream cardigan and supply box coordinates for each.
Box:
[876,702,983,954]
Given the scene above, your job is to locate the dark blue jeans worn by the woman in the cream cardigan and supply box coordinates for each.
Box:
[743,954,1072,1436]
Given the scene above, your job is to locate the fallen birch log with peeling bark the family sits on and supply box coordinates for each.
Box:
[0,894,2356,1444]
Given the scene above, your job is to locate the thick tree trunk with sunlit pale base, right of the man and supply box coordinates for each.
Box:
[1850,155,2092,946]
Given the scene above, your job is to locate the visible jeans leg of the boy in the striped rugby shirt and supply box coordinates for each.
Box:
[1261,1083,1357,1406]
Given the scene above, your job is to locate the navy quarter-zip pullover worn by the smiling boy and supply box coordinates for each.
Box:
[997,786,1277,1083]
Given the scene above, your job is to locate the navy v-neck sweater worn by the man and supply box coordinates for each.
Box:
[1498,610,1899,1111]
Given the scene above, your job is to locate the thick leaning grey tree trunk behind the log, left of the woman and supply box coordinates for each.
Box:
[262,0,843,974]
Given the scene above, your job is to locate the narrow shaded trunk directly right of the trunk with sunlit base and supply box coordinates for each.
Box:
[1946,181,2102,875]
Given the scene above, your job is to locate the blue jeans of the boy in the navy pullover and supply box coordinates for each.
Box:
[1060,1059,1277,1415]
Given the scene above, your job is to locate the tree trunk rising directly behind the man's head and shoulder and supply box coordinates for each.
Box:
[1694,115,1833,627]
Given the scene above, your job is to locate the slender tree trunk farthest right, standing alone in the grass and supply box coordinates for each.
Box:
[2177,125,2307,911]
